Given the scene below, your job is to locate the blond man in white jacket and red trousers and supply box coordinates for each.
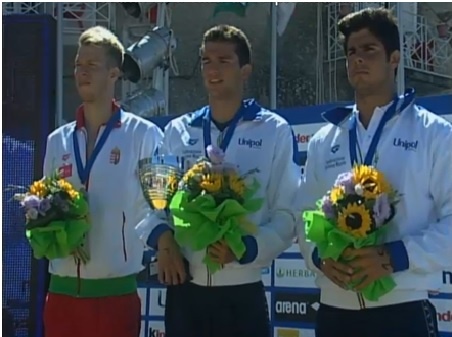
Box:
[44,27,183,337]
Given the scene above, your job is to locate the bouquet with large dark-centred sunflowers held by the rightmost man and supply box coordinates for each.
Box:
[303,165,399,301]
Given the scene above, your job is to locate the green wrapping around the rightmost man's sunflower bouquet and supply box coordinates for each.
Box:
[303,211,396,301]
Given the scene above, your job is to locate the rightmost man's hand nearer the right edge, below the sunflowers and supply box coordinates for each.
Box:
[342,246,393,291]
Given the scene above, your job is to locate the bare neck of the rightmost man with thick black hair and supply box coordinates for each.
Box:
[355,86,394,127]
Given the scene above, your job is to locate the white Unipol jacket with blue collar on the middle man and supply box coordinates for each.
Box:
[154,101,300,286]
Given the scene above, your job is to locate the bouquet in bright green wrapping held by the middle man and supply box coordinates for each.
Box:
[170,146,263,273]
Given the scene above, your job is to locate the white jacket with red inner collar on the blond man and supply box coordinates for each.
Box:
[44,110,164,279]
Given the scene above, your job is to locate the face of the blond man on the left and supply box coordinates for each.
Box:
[74,45,119,102]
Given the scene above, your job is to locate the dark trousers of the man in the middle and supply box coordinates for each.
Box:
[165,282,271,337]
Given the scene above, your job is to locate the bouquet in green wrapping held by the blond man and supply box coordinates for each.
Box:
[14,174,90,263]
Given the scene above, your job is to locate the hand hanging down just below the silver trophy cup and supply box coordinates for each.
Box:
[157,231,187,285]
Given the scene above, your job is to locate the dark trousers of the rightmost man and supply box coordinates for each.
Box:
[315,300,439,337]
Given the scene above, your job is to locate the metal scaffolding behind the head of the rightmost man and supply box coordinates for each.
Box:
[324,2,452,101]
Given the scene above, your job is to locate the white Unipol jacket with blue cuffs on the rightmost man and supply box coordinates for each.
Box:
[298,90,452,309]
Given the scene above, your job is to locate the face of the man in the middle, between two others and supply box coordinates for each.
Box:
[201,42,251,99]
